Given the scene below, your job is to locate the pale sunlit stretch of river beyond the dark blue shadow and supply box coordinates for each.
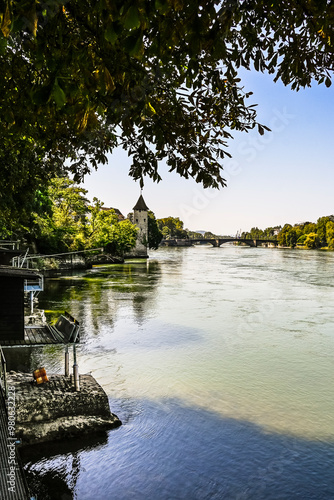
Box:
[71,248,334,439]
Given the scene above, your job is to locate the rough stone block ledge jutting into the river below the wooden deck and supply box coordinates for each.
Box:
[7,371,122,445]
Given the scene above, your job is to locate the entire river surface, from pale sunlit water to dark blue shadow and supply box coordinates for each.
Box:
[11,245,334,500]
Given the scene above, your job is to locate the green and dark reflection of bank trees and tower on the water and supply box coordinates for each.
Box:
[39,260,161,334]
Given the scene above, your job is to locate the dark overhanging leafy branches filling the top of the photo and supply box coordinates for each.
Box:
[0,0,334,219]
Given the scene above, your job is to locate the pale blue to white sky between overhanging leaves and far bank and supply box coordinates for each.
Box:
[79,67,334,234]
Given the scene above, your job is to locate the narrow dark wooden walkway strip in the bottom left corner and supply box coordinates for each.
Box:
[0,391,31,500]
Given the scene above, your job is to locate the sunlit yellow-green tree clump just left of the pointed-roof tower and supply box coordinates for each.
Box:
[29,178,137,256]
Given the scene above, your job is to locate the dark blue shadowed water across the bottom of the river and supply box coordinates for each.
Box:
[20,400,334,500]
